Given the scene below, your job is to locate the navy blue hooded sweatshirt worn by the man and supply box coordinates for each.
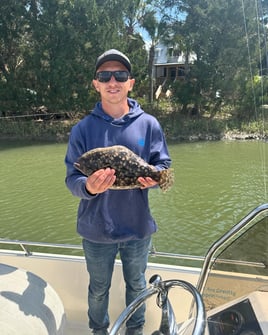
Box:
[65,99,171,243]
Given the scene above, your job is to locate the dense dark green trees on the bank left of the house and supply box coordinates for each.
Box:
[0,0,146,113]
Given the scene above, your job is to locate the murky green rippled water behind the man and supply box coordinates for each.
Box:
[0,141,268,255]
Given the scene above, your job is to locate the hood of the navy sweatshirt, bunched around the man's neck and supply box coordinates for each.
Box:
[91,98,144,126]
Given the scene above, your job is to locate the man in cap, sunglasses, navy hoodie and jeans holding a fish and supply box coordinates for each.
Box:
[65,49,171,335]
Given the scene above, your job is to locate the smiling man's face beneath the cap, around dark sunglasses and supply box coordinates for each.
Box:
[92,61,135,104]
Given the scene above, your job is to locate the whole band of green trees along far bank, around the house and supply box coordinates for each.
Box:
[0,0,268,133]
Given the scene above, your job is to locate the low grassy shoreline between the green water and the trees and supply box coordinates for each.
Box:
[0,113,268,142]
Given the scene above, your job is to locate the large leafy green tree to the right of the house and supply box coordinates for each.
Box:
[166,0,264,120]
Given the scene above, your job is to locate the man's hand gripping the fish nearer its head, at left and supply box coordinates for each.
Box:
[86,168,116,194]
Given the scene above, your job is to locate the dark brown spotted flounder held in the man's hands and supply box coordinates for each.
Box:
[74,145,174,192]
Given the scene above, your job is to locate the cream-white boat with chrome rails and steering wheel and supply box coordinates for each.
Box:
[0,204,268,335]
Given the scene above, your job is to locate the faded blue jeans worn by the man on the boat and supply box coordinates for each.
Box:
[83,237,151,330]
